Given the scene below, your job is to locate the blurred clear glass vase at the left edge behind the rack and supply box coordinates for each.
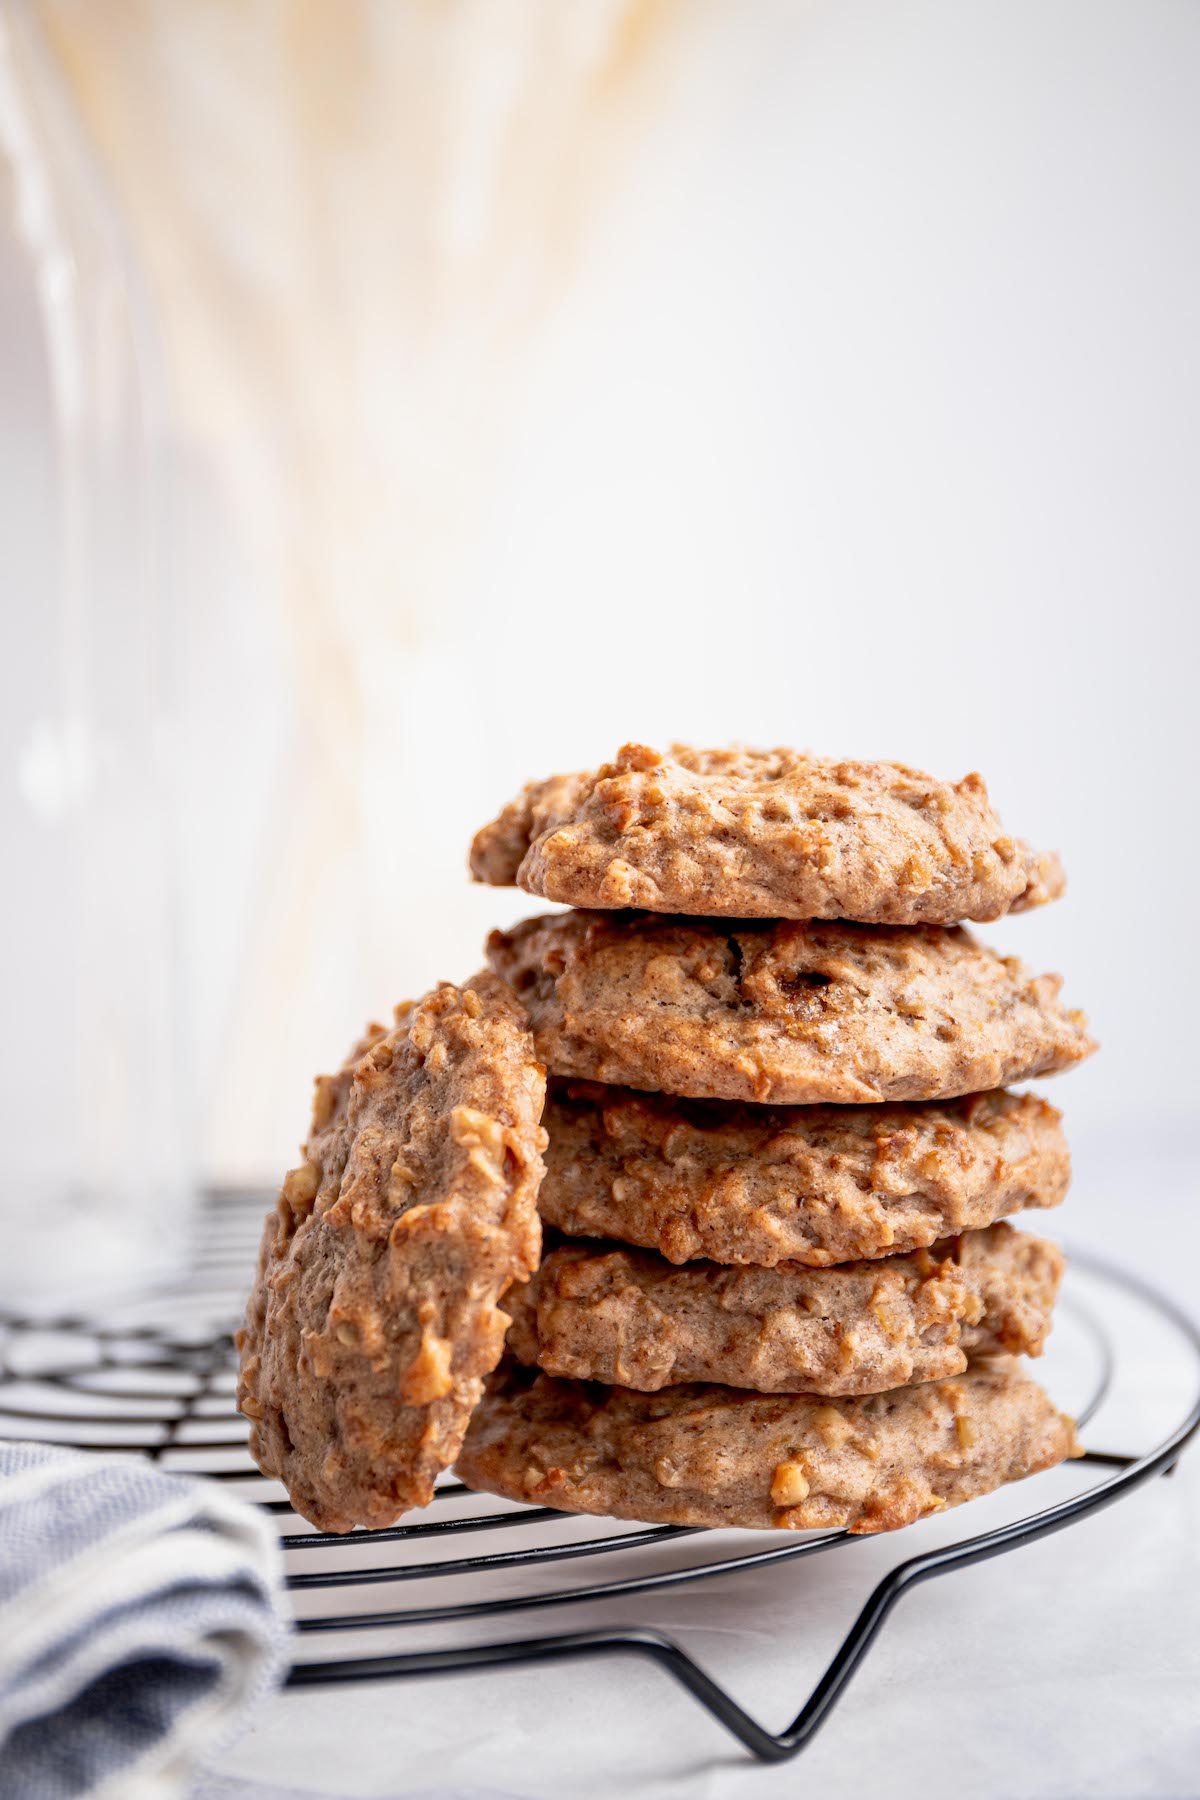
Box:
[0,4,193,1307]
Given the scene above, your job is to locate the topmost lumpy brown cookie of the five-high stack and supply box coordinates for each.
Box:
[471,743,1065,925]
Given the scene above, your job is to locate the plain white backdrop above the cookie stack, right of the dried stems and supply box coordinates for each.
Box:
[448,5,1200,1152]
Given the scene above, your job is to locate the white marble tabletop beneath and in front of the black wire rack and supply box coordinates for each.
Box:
[211,1132,1200,1800]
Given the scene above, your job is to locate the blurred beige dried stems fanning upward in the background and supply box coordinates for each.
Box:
[38,0,678,1173]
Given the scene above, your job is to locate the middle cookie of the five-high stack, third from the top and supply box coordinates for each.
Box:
[538,1082,1070,1269]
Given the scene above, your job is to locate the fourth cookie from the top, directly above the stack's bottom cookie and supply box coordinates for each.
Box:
[504,1226,1063,1395]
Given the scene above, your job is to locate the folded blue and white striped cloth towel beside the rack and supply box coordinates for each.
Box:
[0,1444,288,1800]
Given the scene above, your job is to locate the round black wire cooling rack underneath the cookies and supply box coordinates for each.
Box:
[0,1193,1200,1760]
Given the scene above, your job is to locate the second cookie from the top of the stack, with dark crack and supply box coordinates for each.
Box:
[488,913,1096,1105]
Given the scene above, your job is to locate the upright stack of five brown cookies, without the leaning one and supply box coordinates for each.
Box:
[457,747,1094,1532]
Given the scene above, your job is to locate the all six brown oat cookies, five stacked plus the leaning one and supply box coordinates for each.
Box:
[237,747,1092,1532]
